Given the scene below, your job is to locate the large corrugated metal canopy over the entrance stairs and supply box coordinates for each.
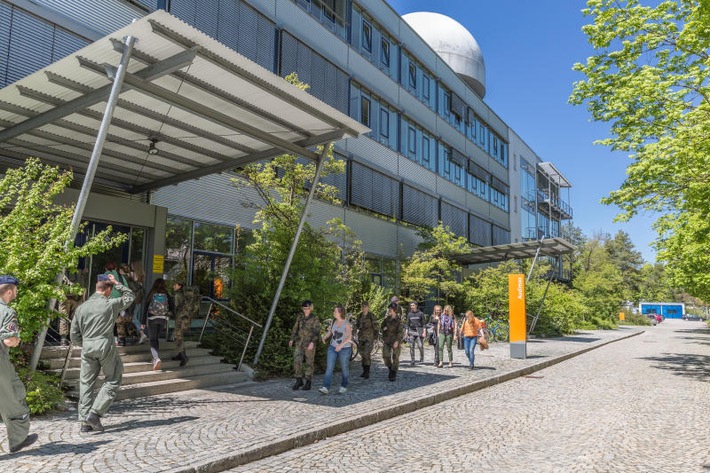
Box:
[0,10,369,193]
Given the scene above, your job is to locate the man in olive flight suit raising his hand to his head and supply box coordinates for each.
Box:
[71,274,134,432]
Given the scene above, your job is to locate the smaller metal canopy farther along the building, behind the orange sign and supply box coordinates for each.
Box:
[455,238,575,264]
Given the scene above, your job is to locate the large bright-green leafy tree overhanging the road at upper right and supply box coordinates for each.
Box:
[570,0,710,295]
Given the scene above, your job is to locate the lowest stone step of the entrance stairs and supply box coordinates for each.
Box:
[67,365,249,400]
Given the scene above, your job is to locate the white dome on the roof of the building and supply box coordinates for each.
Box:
[402,12,486,97]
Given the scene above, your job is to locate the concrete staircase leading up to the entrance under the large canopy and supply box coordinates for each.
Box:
[40,340,249,399]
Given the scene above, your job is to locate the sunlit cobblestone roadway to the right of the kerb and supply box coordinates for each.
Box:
[230,320,710,473]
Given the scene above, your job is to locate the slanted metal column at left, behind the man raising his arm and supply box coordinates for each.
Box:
[30,36,138,371]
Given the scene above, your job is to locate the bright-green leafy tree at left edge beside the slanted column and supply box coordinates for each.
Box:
[0,158,127,342]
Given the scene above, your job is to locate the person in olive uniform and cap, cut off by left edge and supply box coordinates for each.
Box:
[0,276,37,453]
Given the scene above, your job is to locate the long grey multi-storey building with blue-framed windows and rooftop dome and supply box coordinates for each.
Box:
[0,0,572,295]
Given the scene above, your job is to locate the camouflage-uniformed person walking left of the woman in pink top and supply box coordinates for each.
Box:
[288,301,320,391]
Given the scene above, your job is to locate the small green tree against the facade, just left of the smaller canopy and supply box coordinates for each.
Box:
[401,223,471,304]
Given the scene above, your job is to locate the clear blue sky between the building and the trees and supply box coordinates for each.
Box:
[389,0,656,262]
